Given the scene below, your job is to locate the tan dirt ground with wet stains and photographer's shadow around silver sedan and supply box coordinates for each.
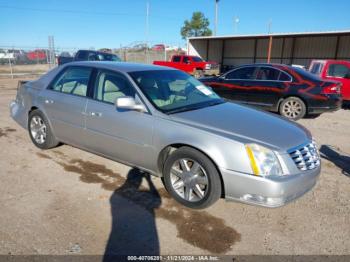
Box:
[0,79,350,255]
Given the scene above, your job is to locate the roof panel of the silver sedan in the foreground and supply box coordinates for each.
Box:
[65,61,175,73]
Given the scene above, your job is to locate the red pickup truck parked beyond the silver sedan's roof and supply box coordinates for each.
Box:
[153,55,220,78]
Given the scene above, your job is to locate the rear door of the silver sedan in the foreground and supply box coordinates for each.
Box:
[39,66,92,146]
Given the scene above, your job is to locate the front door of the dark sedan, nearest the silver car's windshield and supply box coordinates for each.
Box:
[211,66,256,103]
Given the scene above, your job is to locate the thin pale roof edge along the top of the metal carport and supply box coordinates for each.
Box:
[188,30,350,40]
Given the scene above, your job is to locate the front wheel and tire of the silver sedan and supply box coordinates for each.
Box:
[163,147,221,209]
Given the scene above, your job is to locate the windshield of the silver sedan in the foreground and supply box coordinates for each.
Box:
[129,70,224,114]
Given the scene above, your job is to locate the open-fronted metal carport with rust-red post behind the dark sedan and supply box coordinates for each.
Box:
[188,31,350,70]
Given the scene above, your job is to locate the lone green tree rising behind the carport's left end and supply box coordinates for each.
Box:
[181,12,212,39]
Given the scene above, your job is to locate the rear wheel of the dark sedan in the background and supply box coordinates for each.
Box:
[279,96,306,121]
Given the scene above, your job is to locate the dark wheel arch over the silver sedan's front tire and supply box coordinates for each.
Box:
[157,143,225,197]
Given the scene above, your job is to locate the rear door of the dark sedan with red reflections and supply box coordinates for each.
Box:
[245,66,291,108]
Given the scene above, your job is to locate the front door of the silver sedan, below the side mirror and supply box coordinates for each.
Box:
[86,70,154,169]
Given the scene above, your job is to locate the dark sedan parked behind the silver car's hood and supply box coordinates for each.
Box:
[200,64,342,120]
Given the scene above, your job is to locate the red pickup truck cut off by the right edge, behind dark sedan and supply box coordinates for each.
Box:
[309,60,350,107]
